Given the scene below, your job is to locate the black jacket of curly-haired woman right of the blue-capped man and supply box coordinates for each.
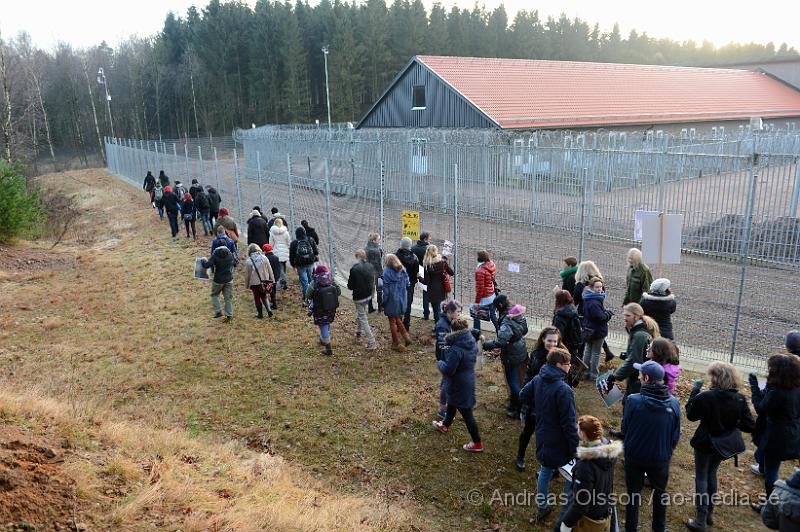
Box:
[686,388,756,453]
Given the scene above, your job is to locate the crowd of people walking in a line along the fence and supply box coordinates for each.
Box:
[143,172,800,532]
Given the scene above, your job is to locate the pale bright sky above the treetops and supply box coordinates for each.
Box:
[0,0,800,49]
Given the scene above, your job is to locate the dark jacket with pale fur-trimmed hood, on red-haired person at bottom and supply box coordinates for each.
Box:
[561,440,622,528]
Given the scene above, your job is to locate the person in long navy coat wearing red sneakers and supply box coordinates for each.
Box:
[434,316,483,453]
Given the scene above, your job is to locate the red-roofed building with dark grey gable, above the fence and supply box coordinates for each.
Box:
[357,56,800,132]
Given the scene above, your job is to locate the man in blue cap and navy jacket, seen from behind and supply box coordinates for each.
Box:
[622,360,681,532]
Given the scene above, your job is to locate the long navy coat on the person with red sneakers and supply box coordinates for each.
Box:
[436,329,478,408]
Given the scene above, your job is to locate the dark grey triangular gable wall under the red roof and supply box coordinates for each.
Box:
[358,61,497,128]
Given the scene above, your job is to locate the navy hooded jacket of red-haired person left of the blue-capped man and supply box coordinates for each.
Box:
[519,364,579,468]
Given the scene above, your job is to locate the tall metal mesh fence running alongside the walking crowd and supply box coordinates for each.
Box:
[106,127,800,369]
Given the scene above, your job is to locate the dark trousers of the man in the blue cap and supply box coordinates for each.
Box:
[625,461,669,532]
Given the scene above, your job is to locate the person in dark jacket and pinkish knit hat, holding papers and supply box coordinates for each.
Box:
[483,294,528,419]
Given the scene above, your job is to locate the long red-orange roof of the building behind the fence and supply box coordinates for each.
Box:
[417,55,800,128]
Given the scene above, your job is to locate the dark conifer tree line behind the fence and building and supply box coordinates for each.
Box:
[0,0,798,168]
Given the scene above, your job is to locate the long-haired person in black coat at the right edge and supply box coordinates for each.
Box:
[749,354,800,500]
